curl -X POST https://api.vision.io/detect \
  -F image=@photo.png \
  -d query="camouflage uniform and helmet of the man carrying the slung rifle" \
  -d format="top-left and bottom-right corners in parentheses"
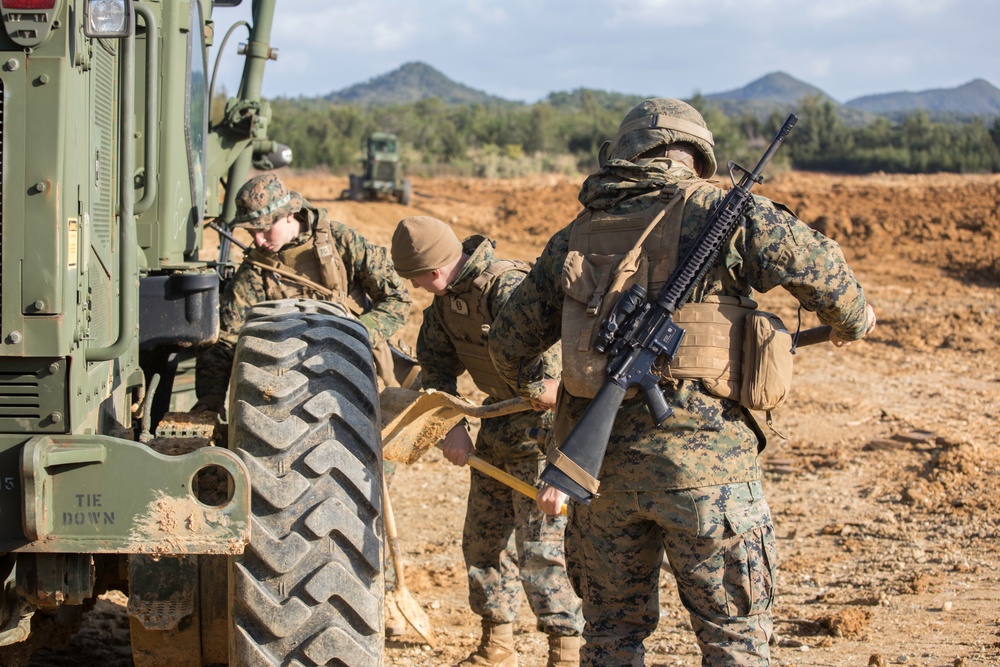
top-left (489, 99), bottom-right (874, 667)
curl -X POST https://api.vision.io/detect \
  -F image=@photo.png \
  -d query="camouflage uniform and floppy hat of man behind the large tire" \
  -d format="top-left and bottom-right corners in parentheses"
top-left (196, 174), bottom-right (412, 412)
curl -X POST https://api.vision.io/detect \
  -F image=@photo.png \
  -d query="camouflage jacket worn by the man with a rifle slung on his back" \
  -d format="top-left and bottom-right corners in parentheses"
top-left (489, 159), bottom-right (866, 492)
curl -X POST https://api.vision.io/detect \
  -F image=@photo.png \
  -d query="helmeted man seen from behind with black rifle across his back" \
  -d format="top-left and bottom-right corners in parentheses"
top-left (489, 99), bottom-right (875, 667)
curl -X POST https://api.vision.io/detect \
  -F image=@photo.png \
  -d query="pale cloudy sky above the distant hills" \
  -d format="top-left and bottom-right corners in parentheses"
top-left (210, 0), bottom-right (1000, 102)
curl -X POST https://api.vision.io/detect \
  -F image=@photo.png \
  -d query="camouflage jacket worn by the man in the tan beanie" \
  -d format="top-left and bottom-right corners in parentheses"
top-left (417, 236), bottom-right (562, 464)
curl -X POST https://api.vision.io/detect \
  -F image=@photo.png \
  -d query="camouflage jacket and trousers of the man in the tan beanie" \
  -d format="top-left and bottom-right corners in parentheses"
top-left (417, 236), bottom-right (583, 636)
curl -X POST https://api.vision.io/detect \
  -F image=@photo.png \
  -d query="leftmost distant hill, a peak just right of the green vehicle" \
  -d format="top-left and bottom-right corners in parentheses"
top-left (323, 62), bottom-right (510, 105)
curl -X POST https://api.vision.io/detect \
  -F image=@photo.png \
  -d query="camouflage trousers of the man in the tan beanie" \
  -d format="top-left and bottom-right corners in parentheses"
top-left (462, 460), bottom-right (583, 636)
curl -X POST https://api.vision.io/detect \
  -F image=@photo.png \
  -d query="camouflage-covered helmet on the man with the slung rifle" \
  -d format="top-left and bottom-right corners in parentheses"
top-left (608, 97), bottom-right (718, 178)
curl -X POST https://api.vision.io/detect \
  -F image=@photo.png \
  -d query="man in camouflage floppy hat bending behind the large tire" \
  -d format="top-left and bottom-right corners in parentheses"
top-left (192, 174), bottom-right (412, 636)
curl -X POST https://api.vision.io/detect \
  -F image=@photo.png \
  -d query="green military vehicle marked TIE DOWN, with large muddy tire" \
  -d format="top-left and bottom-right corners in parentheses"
top-left (0, 0), bottom-right (384, 667)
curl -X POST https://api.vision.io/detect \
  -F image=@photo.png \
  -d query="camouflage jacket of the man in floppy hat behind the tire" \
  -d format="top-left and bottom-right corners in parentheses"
top-left (196, 202), bottom-right (412, 408)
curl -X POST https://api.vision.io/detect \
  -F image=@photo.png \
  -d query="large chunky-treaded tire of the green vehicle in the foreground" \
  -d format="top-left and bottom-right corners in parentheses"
top-left (229, 300), bottom-right (384, 667)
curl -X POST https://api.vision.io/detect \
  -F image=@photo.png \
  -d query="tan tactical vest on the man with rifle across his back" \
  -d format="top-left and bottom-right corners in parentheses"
top-left (561, 180), bottom-right (756, 398)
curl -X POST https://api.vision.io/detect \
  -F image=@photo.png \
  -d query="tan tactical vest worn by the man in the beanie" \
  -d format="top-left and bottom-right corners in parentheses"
top-left (434, 259), bottom-right (530, 399)
